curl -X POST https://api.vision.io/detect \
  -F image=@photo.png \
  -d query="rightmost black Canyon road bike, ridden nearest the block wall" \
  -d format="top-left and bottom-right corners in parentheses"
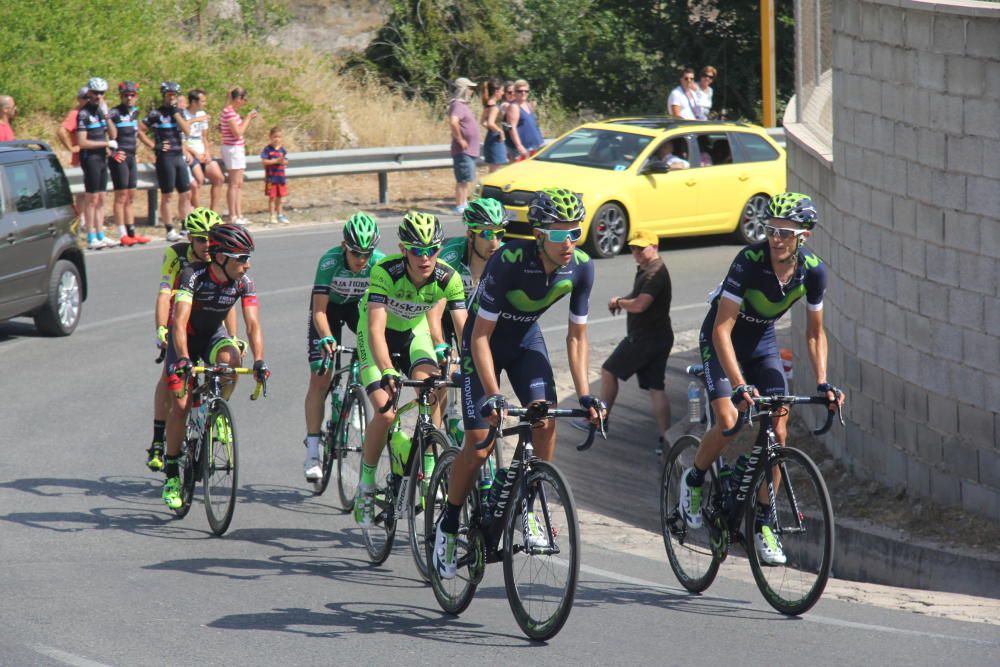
top-left (660, 365), bottom-right (843, 616)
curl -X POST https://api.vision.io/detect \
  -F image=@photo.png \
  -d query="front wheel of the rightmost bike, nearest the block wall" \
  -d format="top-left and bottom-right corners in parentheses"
top-left (745, 447), bottom-right (833, 616)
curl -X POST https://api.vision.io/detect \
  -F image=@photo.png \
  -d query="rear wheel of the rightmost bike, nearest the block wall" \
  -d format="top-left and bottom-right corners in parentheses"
top-left (660, 435), bottom-right (719, 593)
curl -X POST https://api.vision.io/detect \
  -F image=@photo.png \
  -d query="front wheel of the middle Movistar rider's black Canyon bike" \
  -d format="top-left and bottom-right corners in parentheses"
top-left (503, 461), bottom-right (580, 641)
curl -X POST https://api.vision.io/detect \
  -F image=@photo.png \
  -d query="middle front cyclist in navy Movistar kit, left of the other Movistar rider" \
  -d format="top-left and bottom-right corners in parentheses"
top-left (433, 188), bottom-right (604, 578)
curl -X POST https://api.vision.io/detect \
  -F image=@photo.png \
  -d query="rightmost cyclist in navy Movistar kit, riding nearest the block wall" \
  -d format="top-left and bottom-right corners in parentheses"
top-left (680, 192), bottom-right (844, 565)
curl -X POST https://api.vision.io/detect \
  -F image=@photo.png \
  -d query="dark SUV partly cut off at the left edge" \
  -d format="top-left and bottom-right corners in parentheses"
top-left (0, 141), bottom-right (87, 336)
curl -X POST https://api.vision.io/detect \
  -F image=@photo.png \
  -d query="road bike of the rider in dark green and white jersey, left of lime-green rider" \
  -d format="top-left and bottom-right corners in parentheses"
top-left (313, 345), bottom-right (368, 512)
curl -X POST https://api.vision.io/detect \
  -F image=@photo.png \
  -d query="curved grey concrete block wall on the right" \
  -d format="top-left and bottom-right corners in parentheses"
top-left (785, 0), bottom-right (1000, 520)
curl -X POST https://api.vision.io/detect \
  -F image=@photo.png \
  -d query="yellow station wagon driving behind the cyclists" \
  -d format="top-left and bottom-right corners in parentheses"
top-left (480, 117), bottom-right (785, 257)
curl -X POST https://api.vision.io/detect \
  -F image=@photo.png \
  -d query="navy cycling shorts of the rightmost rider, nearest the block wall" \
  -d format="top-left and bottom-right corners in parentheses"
top-left (698, 326), bottom-right (788, 402)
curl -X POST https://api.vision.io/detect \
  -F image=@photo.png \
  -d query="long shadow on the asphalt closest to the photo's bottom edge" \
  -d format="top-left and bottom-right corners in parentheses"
top-left (208, 602), bottom-right (541, 648)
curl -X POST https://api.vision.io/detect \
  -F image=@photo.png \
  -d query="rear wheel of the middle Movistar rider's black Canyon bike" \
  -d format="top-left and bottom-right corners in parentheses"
top-left (424, 448), bottom-right (486, 616)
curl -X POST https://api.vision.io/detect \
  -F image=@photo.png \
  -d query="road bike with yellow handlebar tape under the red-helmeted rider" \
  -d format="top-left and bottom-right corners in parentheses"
top-left (174, 364), bottom-right (267, 535)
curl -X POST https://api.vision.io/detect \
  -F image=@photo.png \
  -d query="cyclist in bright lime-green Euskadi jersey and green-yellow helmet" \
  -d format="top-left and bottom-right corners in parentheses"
top-left (354, 211), bottom-right (466, 529)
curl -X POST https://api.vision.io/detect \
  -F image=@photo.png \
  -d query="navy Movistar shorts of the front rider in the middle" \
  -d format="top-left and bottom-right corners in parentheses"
top-left (461, 322), bottom-right (557, 431)
